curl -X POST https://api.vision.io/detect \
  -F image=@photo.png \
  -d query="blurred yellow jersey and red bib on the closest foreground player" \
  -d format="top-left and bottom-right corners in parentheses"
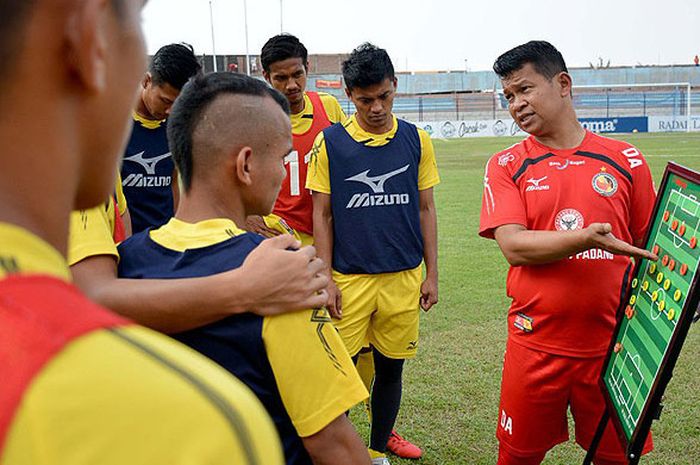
top-left (0, 223), bottom-right (283, 465)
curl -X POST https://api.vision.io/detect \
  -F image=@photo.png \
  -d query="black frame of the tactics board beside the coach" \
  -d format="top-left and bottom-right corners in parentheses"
top-left (584, 162), bottom-right (700, 465)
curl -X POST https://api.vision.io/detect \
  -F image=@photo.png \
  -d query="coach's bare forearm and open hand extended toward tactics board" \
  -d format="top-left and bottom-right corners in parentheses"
top-left (494, 223), bottom-right (657, 266)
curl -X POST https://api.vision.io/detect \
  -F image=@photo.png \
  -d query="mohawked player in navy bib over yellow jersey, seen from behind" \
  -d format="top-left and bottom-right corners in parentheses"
top-left (119, 73), bottom-right (369, 465)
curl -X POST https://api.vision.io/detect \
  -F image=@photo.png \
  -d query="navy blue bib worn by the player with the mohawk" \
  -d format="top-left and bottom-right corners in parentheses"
top-left (118, 230), bottom-right (312, 465)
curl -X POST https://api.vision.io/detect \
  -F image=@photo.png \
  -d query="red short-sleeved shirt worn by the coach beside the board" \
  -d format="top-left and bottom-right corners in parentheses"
top-left (479, 132), bottom-right (656, 357)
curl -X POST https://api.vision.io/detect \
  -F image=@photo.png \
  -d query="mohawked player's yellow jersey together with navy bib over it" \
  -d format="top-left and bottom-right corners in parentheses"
top-left (119, 218), bottom-right (368, 463)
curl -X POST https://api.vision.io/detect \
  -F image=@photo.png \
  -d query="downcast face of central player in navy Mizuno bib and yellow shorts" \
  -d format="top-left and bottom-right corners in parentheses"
top-left (345, 78), bottom-right (397, 134)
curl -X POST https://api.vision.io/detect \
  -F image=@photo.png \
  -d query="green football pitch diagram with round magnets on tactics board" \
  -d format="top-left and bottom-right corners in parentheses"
top-left (603, 165), bottom-right (700, 441)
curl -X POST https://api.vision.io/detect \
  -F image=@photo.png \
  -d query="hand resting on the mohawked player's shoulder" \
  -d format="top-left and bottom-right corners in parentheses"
top-left (241, 234), bottom-right (329, 315)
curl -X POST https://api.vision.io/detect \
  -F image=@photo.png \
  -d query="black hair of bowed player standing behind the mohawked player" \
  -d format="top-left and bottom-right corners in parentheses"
top-left (148, 43), bottom-right (202, 90)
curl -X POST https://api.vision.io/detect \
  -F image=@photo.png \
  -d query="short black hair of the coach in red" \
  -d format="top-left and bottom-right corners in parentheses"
top-left (493, 40), bottom-right (569, 79)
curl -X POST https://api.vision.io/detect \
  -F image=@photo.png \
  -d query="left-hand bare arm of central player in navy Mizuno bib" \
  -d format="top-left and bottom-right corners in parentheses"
top-left (313, 191), bottom-right (343, 319)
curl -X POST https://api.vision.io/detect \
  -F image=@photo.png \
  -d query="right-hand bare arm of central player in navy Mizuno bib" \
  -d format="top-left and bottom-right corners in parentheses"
top-left (418, 187), bottom-right (438, 312)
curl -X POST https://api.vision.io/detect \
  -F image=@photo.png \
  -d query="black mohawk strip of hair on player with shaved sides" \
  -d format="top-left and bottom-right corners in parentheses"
top-left (167, 73), bottom-right (289, 191)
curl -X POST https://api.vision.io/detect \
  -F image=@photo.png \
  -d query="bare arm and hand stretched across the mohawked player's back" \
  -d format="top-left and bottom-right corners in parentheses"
top-left (71, 235), bottom-right (329, 333)
